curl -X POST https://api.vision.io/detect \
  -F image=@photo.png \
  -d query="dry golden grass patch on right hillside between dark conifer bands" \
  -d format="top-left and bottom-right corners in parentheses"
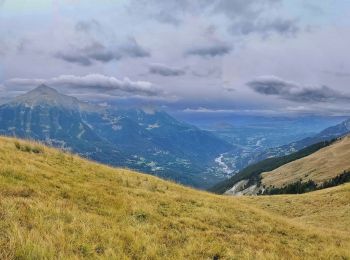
top-left (261, 136), bottom-right (350, 187)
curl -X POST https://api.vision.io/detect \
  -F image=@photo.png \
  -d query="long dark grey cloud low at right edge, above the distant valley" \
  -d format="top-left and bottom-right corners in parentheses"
top-left (246, 76), bottom-right (350, 103)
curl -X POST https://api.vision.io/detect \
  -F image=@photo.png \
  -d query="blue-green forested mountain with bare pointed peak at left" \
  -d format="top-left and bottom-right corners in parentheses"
top-left (0, 85), bottom-right (232, 188)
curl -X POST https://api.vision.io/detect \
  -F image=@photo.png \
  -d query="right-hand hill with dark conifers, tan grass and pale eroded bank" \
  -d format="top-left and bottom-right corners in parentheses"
top-left (211, 136), bottom-right (350, 195)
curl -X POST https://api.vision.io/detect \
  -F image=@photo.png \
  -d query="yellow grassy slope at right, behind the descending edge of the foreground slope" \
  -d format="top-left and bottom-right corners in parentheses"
top-left (238, 184), bottom-right (350, 234)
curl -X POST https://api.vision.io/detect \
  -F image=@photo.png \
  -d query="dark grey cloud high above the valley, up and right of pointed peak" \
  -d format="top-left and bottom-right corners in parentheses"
top-left (55, 38), bottom-right (150, 66)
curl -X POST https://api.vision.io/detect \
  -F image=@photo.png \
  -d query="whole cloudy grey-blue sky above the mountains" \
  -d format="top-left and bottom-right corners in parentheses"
top-left (0, 0), bottom-right (350, 115)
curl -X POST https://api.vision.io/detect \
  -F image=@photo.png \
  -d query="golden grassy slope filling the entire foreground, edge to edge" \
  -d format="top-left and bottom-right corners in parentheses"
top-left (0, 138), bottom-right (350, 259)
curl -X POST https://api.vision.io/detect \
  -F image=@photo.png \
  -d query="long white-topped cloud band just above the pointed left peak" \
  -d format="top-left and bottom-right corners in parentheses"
top-left (5, 74), bottom-right (163, 97)
